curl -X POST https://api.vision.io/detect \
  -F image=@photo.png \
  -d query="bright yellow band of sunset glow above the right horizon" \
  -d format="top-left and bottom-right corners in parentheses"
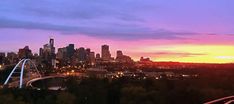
top-left (133, 45), bottom-right (234, 63)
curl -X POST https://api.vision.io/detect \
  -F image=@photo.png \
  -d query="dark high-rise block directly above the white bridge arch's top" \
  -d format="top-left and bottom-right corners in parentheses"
top-left (18, 46), bottom-right (32, 59)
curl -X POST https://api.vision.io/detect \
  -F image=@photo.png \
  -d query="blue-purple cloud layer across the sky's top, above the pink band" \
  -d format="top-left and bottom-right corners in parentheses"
top-left (0, 0), bottom-right (234, 40)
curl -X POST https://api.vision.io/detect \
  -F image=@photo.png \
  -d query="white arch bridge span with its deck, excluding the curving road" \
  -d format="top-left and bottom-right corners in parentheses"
top-left (4, 59), bottom-right (41, 88)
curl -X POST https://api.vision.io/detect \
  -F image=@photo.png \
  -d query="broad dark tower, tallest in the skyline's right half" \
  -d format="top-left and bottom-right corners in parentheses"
top-left (102, 45), bottom-right (111, 61)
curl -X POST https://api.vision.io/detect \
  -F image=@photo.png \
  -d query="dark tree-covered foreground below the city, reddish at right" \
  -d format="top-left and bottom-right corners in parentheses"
top-left (0, 63), bottom-right (234, 104)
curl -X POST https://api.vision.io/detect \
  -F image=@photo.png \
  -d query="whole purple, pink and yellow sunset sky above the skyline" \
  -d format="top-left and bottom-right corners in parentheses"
top-left (0, 0), bottom-right (234, 63)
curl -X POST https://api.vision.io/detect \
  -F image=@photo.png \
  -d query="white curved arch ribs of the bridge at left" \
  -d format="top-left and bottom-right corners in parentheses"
top-left (4, 59), bottom-right (41, 88)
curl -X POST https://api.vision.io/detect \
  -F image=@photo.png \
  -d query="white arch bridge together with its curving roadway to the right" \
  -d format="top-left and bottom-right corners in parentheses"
top-left (4, 59), bottom-right (66, 90)
